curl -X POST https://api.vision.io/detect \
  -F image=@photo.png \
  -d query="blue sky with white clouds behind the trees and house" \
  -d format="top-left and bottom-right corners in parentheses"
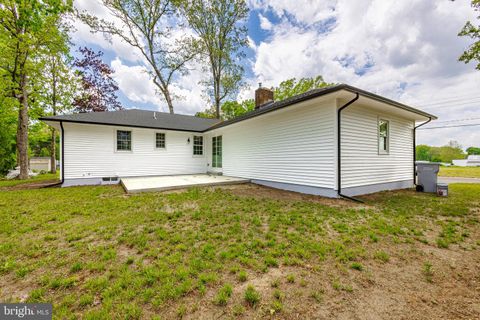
top-left (73, 0), bottom-right (480, 146)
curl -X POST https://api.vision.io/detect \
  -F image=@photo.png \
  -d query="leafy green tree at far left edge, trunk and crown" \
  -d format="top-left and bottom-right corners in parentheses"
top-left (0, 0), bottom-right (72, 179)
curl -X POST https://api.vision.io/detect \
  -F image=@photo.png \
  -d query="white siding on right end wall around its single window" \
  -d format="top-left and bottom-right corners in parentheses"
top-left (342, 105), bottom-right (413, 188)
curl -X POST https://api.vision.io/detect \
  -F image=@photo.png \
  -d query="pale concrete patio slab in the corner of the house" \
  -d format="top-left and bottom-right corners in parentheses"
top-left (120, 174), bottom-right (250, 193)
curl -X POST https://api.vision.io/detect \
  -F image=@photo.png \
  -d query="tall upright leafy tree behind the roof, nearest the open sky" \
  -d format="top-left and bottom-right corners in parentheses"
top-left (180, 0), bottom-right (249, 118)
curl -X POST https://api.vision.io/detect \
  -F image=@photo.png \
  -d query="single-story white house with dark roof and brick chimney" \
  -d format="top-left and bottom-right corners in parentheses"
top-left (42, 84), bottom-right (436, 197)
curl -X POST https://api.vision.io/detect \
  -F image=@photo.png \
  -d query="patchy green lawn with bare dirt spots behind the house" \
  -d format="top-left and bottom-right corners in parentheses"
top-left (0, 181), bottom-right (480, 319)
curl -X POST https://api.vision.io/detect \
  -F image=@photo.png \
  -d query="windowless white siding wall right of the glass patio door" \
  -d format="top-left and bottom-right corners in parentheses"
top-left (206, 100), bottom-right (336, 188)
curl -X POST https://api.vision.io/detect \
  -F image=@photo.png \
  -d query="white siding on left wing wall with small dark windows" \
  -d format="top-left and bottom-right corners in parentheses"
top-left (64, 123), bottom-right (206, 179)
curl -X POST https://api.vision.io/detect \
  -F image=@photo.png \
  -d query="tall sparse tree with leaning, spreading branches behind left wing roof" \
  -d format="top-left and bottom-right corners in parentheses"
top-left (79, 0), bottom-right (198, 114)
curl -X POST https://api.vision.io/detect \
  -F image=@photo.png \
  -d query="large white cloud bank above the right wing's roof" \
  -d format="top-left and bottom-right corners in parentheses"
top-left (252, 0), bottom-right (480, 145)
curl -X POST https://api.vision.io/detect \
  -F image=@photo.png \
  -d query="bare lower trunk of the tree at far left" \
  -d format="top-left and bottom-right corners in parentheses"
top-left (17, 75), bottom-right (29, 179)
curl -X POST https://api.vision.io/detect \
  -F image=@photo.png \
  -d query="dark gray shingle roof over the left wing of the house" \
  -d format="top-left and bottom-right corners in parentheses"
top-left (40, 109), bottom-right (219, 132)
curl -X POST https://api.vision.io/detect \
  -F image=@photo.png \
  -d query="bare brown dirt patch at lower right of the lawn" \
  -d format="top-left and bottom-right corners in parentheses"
top-left (157, 234), bottom-right (480, 320)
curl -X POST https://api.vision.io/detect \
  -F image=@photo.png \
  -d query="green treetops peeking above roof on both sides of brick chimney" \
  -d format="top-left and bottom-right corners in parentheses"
top-left (196, 76), bottom-right (332, 120)
